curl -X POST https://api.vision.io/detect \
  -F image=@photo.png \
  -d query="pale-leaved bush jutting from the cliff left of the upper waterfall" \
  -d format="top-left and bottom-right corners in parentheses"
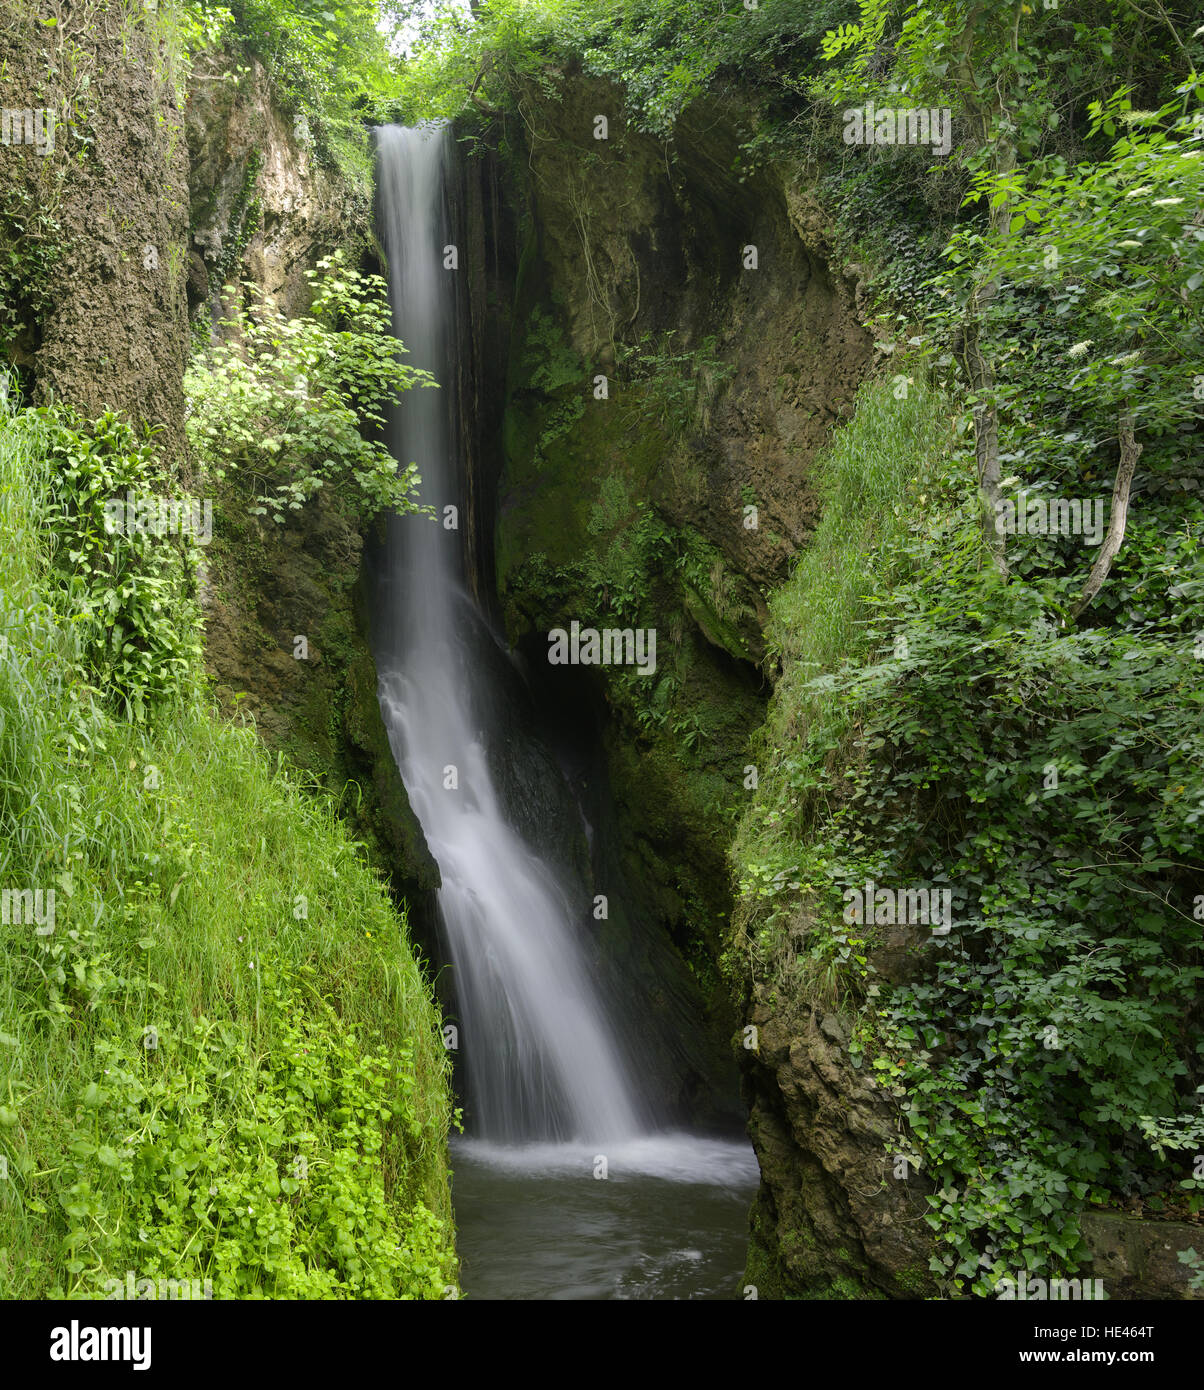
top-left (185, 252), bottom-right (434, 523)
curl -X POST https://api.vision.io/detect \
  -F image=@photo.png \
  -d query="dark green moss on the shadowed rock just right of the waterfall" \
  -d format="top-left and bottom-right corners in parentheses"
top-left (495, 261), bottom-right (763, 1128)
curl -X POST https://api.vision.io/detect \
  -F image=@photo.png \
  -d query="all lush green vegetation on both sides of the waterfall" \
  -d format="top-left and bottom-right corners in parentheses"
top-left (9, 0), bottom-right (1204, 1297)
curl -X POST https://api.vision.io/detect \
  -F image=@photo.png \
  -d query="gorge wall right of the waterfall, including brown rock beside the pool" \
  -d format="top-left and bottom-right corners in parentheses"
top-left (475, 72), bottom-right (1193, 1300)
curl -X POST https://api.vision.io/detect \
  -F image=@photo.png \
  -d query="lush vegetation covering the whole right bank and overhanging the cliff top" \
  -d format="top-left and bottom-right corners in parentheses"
top-left (405, 0), bottom-right (1204, 1294)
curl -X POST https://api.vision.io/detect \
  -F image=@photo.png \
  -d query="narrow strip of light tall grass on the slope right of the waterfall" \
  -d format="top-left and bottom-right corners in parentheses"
top-left (729, 378), bottom-right (954, 969)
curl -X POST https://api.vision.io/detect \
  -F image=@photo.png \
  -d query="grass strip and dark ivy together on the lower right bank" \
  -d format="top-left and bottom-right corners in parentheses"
top-left (730, 366), bottom-right (1204, 1294)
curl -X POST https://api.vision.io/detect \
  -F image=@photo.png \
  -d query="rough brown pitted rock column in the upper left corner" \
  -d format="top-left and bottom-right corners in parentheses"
top-left (0, 3), bottom-right (188, 463)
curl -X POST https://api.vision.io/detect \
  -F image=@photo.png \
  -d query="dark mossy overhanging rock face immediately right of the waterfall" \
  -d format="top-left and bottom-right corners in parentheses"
top-left (495, 74), bottom-right (870, 1128)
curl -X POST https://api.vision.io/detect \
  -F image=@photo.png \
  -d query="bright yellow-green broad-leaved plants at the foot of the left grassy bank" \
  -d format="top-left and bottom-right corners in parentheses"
top-left (61, 965), bottom-right (450, 1298)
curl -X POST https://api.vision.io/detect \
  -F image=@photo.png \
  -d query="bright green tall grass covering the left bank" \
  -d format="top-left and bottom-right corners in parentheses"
top-left (0, 394), bottom-right (455, 1297)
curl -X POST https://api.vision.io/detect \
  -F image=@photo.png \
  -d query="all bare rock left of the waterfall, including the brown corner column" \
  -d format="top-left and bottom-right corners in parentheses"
top-left (0, 16), bottom-right (438, 894)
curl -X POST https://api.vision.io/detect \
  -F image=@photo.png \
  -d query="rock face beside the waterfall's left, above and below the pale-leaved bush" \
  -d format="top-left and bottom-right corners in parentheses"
top-left (188, 56), bottom-right (439, 899)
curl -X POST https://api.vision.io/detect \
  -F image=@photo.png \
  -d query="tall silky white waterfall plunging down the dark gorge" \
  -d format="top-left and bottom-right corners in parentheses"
top-left (375, 126), bottom-right (646, 1144)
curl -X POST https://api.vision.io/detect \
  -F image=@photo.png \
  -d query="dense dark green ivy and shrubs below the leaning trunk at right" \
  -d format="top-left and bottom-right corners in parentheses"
top-left (845, 558), bottom-right (1204, 1289)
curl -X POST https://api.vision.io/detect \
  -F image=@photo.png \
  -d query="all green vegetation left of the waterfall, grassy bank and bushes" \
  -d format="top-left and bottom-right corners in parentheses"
top-left (0, 3), bottom-right (457, 1298)
